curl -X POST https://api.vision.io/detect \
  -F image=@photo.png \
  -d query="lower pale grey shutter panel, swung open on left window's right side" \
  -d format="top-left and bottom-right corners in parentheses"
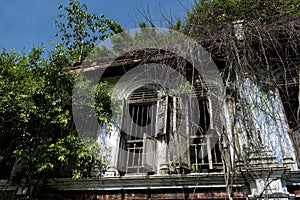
top-left (142, 133), bottom-right (155, 171)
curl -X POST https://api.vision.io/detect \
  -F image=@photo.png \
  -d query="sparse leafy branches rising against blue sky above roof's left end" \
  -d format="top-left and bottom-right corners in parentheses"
top-left (55, 0), bottom-right (123, 64)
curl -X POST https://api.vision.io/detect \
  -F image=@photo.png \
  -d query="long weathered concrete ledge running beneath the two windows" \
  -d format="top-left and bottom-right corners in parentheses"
top-left (46, 173), bottom-right (244, 191)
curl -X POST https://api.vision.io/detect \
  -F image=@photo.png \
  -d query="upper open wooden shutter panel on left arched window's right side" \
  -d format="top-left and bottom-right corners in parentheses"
top-left (155, 97), bottom-right (168, 137)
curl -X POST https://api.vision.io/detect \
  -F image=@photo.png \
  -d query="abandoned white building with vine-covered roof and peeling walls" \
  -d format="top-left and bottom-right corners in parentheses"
top-left (3, 27), bottom-right (300, 200)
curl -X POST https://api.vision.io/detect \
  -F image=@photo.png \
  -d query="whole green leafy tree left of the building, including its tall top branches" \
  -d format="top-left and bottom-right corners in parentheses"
top-left (0, 0), bottom-right (122, 180)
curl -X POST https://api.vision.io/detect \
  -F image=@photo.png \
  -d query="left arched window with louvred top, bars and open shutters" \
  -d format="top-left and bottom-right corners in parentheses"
top-left (118, 85), bottom-right (164, 173)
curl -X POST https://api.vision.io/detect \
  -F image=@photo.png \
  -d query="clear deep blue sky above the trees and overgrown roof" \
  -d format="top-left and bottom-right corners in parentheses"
top-left (0, 0), bottom-right (195, 52)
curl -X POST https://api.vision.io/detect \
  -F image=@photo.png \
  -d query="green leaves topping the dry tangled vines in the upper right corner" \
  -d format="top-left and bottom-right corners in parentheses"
top-left (187, 0), bottom-right (300, 26)
